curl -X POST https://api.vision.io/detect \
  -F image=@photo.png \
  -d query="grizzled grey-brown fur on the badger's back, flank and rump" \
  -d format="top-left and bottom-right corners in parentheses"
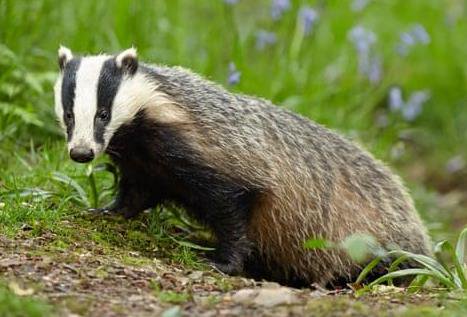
top-left (143, 66), bottom-right (430, 285)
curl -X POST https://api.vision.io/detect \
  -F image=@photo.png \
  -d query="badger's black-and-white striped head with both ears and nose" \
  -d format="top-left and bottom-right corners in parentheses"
top-left (54, 47), bottom-right (141, 163)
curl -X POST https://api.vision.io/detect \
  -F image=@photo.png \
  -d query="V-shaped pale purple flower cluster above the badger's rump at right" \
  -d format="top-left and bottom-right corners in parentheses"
top-left (389, 87), bottom-right (431, 121)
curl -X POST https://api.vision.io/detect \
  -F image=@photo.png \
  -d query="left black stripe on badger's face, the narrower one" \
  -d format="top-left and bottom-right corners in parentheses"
top-left (62, 58), bottom-right (81, 141)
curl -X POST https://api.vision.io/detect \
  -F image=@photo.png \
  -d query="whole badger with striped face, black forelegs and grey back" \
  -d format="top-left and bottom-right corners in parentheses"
top-left (54, 47), bottom-right (430, 286)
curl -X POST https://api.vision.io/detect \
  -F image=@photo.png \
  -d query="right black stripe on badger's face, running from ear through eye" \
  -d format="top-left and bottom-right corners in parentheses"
top-left (94, 58), bottom-right (123, 144)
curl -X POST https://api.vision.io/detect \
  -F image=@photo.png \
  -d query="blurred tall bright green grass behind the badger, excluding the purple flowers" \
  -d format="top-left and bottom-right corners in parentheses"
top-left (0, 0), bottom-right (467, 172)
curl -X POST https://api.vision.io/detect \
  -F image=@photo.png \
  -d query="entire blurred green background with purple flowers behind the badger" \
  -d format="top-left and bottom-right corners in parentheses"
top-left (0, 0), bottom-right (467, 239)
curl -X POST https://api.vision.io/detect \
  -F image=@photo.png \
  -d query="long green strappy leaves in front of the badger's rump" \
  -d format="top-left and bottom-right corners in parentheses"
top-left (305, 227), bottom-right (467, 291)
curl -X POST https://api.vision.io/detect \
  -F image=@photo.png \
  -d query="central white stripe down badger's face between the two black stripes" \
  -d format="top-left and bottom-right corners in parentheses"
top-left (68, 55), bottom-right (110, 155)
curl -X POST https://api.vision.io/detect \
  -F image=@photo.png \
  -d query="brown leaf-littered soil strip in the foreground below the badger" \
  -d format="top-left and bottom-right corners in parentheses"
top-left (0, 228), bottom-right (467, 317)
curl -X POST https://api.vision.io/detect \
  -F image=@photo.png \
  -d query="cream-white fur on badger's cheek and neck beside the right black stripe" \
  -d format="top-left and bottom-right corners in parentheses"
top-left (104, 72), bottom-right (173, 146)
